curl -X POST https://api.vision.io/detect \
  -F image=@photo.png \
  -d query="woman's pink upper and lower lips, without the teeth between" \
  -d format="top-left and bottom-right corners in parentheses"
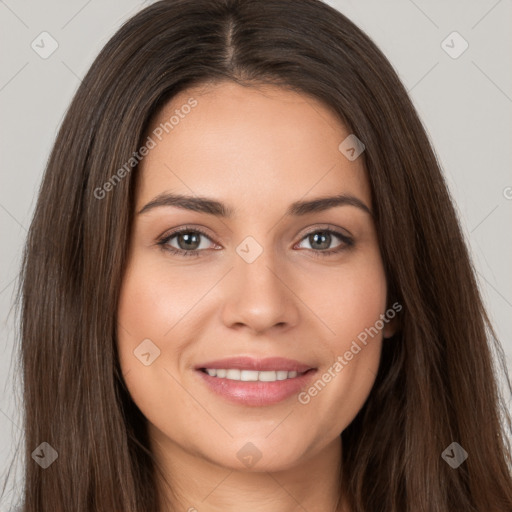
top-left (195, 356), bottom-right (317, 407)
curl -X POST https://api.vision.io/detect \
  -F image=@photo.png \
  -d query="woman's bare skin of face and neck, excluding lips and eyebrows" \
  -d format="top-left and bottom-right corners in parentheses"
top-left (117, 82), bottom-right (395, 512)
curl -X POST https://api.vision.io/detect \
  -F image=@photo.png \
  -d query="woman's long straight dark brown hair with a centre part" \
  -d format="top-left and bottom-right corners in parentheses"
top-left (5, 0), bottom-right (512, 512)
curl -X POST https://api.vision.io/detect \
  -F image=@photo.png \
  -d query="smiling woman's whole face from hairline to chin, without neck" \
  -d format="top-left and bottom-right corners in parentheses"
top-left (117, 82), bottom-right (393, 471)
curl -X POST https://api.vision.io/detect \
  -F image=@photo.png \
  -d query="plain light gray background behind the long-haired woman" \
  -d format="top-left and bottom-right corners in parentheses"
top-left (0, 0), bottom-right (512, 504)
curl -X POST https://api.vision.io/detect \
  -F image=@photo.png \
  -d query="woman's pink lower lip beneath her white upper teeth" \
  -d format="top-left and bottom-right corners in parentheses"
top-left (196, 369), bottom-right (316, 407)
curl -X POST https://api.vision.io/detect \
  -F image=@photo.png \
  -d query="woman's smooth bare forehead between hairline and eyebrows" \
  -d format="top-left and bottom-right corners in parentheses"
top-left (137, 82), bottom-right (371, 212)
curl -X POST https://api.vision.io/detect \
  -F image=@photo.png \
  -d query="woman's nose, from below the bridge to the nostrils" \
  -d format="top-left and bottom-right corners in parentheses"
top-left (222, 242), bottom-right (300, 334)
